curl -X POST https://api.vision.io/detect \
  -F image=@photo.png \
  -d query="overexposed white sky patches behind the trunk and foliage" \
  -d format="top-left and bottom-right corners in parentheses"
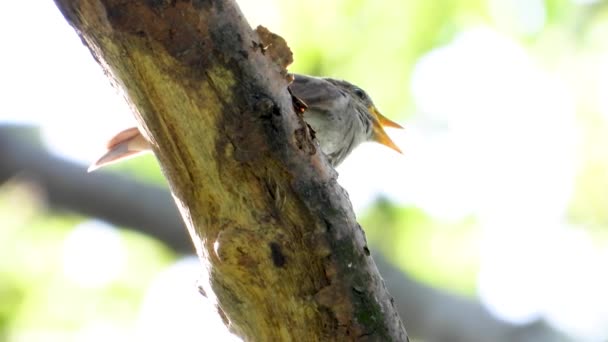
top-left (0, 0), bottom-right (608, 341)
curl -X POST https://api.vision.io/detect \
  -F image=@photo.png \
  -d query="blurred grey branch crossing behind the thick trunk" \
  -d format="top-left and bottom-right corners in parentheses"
top-left (0, 126), bottom-right (565, 342)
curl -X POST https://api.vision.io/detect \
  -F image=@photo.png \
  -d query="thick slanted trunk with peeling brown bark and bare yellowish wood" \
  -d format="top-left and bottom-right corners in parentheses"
top-left (55, 0), bottom-right (407, 341)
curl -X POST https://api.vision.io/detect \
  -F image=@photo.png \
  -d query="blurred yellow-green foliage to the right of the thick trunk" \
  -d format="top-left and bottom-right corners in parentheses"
top-left (279, 0), bottom-right (608, 295)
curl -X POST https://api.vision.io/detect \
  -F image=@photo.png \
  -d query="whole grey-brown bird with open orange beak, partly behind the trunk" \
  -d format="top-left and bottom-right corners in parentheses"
top-left (88, 74), bottom-right (403, 172)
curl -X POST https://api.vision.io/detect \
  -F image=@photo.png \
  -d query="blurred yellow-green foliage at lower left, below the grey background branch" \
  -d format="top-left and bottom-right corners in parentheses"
top-left (0, 180), bottom-right (174, 341)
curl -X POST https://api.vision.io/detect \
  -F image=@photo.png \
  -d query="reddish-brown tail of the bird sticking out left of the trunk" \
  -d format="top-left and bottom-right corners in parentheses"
top-left (88, 127), bottom-right (150, 172)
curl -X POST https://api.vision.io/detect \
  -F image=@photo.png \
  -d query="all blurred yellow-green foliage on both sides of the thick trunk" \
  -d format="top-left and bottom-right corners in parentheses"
top-left (0, 0), bottom-right (608, 341)
